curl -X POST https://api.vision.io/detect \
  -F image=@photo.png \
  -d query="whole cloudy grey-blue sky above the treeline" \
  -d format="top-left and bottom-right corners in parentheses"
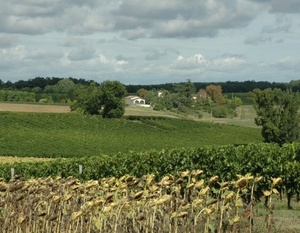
top-left (0, 0), bottom-right (300, 85)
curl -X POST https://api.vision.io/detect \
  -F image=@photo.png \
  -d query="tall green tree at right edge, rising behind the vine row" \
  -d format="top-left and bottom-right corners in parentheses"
top-left (250, 88), bottom-right (300, 145)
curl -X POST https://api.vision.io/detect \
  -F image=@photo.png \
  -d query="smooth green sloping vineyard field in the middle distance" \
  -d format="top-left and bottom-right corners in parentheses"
top-left (0, 109), bottom-right (262, 157)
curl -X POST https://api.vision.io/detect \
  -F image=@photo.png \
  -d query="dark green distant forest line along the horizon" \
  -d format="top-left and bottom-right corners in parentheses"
top-left (0, 77), bottom-right (300, 93)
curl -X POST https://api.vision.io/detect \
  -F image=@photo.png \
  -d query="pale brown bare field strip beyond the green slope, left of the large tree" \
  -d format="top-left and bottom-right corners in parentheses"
top-left (0, 103), bottom-right (70, 113)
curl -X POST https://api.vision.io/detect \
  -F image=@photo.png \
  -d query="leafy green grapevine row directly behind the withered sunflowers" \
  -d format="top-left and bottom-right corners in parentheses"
top-left (0, 143), bottom-right (300, 205)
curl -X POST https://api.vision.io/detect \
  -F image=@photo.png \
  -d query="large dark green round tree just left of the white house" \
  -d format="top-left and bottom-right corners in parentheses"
top-left (71, 81), bottom-right (126, 118)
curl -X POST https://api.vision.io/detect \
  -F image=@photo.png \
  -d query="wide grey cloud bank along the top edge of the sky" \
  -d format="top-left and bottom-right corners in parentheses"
top-left (0, 0), bottom-right (260, 37)
